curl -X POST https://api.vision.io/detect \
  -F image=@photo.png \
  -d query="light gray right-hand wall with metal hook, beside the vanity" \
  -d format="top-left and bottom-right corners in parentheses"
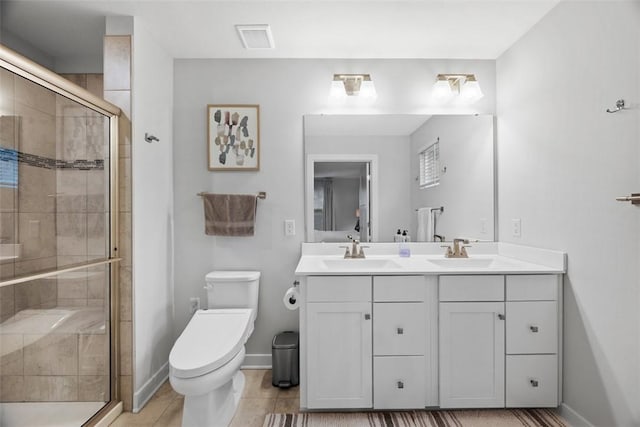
top-left (497, 1), bottom-right (640, 426)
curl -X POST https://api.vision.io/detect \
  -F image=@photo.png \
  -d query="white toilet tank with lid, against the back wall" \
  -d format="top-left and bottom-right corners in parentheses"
top-left (205, 271), bottom-right (260, 312)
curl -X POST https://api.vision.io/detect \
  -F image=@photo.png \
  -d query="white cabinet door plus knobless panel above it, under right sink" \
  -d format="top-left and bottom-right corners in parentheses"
top-left (439, 276), bottom-right (505, 408)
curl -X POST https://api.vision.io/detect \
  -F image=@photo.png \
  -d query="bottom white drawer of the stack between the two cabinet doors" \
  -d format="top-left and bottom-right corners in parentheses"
top-left (373, 356), bottom-right (427, 409)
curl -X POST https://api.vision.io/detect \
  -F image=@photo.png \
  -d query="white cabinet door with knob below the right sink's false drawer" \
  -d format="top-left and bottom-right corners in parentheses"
top-left (440, 302), bottom-right (505, 408)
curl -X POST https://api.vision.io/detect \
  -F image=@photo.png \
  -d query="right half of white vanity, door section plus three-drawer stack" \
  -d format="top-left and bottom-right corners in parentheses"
top-left (439, 274), bottom-right (562, 408)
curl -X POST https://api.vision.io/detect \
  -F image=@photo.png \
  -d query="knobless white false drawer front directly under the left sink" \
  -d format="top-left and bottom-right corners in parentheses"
top-left (306, 276), bottom-right (371, 302)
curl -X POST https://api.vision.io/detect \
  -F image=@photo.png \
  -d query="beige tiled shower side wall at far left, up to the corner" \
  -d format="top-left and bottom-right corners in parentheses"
top-left (0, 69), bottom-right (57, 321)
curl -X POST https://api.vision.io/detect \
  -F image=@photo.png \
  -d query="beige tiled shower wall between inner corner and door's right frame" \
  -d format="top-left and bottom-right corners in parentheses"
top-left (55, 74), bottom-right (109, 310)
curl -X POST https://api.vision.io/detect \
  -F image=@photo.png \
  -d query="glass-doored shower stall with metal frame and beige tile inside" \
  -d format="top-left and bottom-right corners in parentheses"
top-left (0, 46), bottom-right (120, 427)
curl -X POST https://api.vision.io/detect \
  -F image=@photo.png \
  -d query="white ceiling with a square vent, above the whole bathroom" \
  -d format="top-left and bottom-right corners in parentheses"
top-left (1, 0), bottom-right (560, 59)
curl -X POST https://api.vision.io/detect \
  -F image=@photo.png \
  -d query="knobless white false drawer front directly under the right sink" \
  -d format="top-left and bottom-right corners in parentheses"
top-left (439, 275), bottom-right (504, 301)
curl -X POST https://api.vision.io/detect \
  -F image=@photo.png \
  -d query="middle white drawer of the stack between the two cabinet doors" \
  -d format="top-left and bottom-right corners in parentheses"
top-left (373, 302), bottom-right (426, 356)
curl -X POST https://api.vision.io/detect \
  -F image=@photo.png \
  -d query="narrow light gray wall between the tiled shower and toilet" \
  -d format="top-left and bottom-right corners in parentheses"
top-left (131, 18), bottom-right (177, 410)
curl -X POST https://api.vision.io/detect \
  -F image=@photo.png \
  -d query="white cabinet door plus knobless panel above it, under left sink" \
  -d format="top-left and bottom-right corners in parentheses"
top-left (302, 276), bottom-right (373, 409)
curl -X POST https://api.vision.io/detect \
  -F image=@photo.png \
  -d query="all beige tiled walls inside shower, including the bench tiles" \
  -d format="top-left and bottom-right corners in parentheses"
top-left (0, 70), bottom-right (109, 402)
